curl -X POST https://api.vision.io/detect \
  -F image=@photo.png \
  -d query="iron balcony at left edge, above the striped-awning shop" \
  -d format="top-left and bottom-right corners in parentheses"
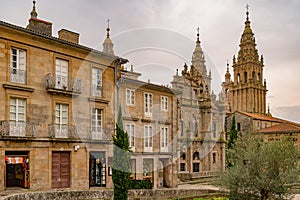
top-left (1, 121), bottom-right (36, 137)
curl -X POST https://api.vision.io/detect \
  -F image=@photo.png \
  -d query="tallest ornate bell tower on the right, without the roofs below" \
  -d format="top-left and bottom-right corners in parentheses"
top-left (222, 5), bottom-right (267, 115)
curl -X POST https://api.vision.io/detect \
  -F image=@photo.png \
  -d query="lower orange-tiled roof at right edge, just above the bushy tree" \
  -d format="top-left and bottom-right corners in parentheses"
top-left (258, 123), bottom-right (300, 133)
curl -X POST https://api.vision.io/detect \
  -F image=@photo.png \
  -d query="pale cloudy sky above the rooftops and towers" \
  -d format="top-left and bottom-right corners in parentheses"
top-left (0, 0), bottom-right (300, 123)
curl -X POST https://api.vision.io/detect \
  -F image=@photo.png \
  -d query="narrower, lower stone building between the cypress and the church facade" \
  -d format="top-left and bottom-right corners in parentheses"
top-left (120, 66), bottom-right (178, 188)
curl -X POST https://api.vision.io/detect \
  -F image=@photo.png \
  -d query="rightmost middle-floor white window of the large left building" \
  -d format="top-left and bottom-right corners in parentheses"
top-left (92, 108), bottom-right (103, 139)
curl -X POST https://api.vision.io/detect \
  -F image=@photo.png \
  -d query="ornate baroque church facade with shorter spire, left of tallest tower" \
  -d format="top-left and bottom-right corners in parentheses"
top-left (172, 29), bottom-right (225, 180)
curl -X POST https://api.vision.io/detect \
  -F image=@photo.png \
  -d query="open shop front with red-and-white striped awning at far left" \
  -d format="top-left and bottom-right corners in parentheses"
top-left (5, 151), bottom-right (30, 188)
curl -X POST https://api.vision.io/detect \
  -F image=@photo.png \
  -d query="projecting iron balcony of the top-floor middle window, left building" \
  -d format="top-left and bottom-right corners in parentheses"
top-left (46, 73), bottom-right (81, 96)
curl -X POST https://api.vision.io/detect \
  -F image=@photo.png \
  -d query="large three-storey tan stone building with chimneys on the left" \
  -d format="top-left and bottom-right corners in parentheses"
top-left (0, 2), bottom-right (127, 191)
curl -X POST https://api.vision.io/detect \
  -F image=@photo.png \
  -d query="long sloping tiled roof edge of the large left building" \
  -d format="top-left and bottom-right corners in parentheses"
top-left (0, 20), bottom-right (128, 64)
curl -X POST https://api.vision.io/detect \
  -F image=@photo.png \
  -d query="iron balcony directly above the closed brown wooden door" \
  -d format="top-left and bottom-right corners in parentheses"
top-left (48, 124), bottom-right (79, 139)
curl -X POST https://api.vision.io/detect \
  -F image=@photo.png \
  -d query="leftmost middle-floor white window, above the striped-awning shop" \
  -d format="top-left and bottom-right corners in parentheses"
top-left (9, 98), bottom-right (26, 136)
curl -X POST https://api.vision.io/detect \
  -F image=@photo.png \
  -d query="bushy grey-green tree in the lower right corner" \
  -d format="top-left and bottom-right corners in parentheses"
top-left (217, 133), bottom-right (299, 200)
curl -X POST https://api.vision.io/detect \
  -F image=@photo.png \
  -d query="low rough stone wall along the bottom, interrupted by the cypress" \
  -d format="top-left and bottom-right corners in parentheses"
top-left (0, 189), bottom-right (225, 200)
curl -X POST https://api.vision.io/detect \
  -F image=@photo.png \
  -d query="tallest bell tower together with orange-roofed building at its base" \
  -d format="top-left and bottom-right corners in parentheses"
top-left (222, 8), bottom-right (300, 155)
